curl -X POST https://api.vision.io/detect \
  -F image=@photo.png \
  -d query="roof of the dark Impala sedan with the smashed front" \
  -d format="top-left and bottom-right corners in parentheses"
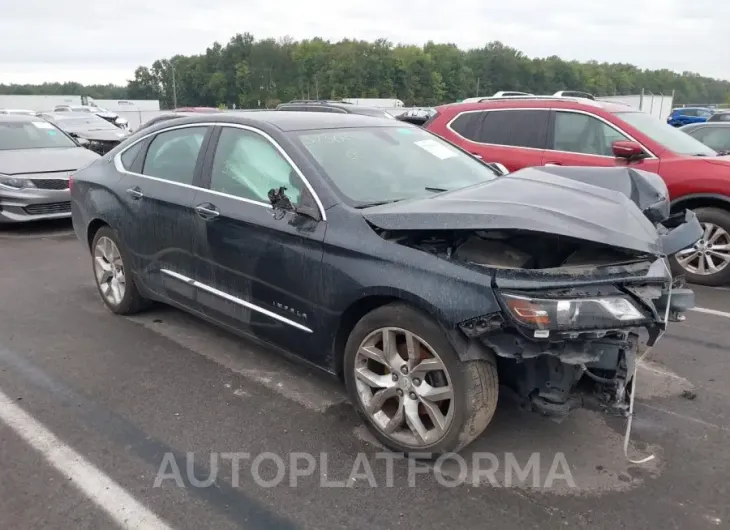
top-left (138, 110), bottom-right (404, 131)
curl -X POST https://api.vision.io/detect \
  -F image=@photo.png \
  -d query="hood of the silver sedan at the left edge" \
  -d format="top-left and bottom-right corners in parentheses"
top-left (0, 147), bottom-right (99, 175)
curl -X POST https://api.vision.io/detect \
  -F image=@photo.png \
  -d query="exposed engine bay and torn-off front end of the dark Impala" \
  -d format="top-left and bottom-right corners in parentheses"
top-left (375, 228), bottom-right (694, 416)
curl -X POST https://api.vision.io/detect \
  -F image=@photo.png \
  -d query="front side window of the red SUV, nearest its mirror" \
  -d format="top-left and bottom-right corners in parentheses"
top-left (553, 112), bottom-right (628, 156)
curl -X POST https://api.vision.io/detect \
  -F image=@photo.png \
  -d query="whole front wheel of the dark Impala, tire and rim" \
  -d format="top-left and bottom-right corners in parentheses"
top-left (344, 303), bottom-right (499, 455)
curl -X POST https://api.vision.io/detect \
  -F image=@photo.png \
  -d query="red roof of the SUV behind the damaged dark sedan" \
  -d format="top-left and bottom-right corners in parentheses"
top-left (437, 96), bottom-right (639, 112)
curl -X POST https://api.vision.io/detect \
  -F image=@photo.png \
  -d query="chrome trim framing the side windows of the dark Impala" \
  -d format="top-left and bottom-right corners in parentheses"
top-left (114, 122), bottom-right (327, 221)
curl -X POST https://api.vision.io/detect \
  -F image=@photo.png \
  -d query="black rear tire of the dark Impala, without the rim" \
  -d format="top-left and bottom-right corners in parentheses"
top-left (91, 226), bottom-right (150, 315)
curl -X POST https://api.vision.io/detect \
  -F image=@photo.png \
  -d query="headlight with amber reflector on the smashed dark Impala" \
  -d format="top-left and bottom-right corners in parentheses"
top-left (502, 293), bottom-right (651, 330)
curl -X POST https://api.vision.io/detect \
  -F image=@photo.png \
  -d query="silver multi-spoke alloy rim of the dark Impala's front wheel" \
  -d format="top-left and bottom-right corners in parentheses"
top-left (354, 327), bottom-right (455, 447)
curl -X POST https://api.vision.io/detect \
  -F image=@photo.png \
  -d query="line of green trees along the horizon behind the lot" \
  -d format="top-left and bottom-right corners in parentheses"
top-left (0, 33), bottom-right (730, 108)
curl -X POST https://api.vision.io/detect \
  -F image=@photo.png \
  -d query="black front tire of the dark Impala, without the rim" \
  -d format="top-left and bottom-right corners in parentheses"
top-left (343, 303), bottom-right (499, 458)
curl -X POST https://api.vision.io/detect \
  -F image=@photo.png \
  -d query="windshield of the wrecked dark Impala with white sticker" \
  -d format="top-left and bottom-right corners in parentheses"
top-left (290, 127), bottom-right (497, 207)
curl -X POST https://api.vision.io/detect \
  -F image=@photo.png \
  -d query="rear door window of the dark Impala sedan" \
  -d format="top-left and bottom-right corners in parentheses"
top-left (142, 127), bottom-right (207, 184)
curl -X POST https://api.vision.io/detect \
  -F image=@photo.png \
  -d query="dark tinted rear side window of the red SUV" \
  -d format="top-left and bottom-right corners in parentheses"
top-left (451, 109), bottom-right (550, 149)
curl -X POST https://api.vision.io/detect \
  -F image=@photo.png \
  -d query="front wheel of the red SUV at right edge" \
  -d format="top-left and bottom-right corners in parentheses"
top-left (674, 208), bottom-right (730, 285)
